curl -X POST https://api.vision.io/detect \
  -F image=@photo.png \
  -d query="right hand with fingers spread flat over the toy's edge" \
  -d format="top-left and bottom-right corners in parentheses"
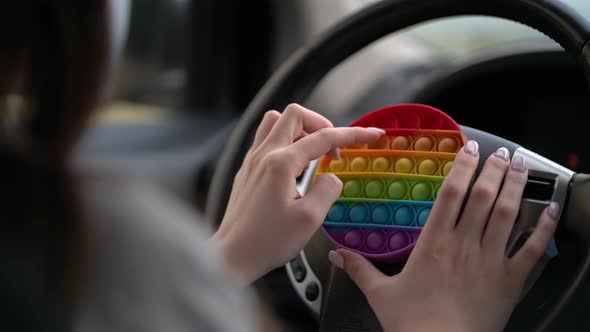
top-left (329, 141), bottom-right (559, 332)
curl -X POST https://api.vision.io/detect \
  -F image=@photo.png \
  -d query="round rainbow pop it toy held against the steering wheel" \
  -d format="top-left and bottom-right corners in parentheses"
top-left (315, 104), bottom-right (466, 262)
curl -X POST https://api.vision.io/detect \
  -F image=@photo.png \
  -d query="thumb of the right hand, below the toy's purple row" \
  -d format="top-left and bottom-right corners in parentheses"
top-left (328, 249), bottom-right (387, 296)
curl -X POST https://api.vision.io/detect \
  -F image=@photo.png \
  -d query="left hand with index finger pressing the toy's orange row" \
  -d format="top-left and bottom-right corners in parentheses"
top-left (212, 104), bottom-right (384, 283)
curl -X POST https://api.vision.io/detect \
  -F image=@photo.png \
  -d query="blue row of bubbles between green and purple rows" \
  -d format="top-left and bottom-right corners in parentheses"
top-left (324, 200), bottom-right (432, 227)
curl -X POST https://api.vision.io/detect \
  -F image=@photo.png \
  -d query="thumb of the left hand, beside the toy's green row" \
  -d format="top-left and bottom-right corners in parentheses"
top-left (302, 173), bottom-right (342, 221)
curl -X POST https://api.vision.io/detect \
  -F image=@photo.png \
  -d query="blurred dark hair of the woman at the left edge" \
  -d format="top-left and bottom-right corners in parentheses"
top-left (0, 0), bottom-right (108, 329)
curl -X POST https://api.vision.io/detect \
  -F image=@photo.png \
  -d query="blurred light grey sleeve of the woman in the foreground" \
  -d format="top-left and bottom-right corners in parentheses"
top-left (78, 171), bottom-right (260, 331)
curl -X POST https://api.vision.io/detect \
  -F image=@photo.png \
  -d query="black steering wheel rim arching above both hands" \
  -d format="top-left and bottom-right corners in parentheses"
top-left (206, 0), bottom-right (590, 326)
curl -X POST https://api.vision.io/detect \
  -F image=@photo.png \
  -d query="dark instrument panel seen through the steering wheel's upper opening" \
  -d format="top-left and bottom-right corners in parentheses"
top-left (409, 40), bottom-right (590, 172)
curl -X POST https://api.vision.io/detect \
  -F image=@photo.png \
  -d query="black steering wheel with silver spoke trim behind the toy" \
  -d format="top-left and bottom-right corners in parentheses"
top-left (206, 0), bottom-right (590, 331)
